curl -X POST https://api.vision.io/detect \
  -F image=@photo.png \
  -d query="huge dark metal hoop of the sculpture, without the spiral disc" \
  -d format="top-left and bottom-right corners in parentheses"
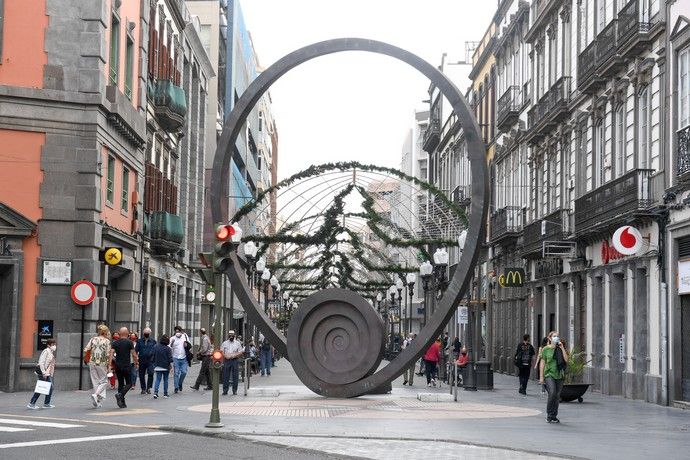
top-left (211, 38), bottom-right (489, 397)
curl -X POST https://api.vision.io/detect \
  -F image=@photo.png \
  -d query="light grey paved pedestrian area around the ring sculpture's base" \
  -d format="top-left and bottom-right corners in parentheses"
top-left (0, 360), bottom-right (690, 460)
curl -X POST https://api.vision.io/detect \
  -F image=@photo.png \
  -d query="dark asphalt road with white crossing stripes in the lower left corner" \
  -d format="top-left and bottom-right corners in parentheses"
top-left (0, 416), bottom-right (350, 460)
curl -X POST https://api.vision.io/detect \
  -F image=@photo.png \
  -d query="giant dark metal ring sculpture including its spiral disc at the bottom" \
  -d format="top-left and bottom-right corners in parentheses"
top-left (211, 38), bottom-right (489, 397)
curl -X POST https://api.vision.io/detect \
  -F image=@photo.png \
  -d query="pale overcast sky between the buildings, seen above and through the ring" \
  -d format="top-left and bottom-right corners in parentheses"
top-left (241, 0), bottom-right (496, 178)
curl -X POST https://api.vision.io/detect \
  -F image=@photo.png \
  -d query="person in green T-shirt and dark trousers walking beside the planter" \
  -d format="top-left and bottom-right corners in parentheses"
top-left (539, 331), bottom-right (568, 423)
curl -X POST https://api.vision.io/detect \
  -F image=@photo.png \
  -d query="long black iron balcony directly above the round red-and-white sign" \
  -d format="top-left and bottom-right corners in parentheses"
top-left (575, 169), bottom-right (653, 236)
